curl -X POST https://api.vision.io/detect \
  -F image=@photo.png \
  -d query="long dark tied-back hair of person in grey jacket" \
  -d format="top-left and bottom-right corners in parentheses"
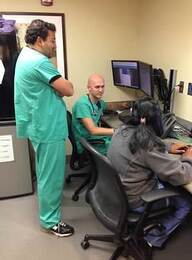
top-left (123, 97), bottom-right (165, 154)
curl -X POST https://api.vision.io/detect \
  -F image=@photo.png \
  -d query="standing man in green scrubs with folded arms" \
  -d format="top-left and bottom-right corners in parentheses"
top-left (15, 19), bottom-right (74, 237)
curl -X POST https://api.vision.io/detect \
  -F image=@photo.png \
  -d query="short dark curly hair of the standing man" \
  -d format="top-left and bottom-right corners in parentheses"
top-left (25, 19), bottom-right (56, 44)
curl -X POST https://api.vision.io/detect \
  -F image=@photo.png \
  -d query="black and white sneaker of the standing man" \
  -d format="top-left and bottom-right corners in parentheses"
top-left (49, 222), bottom-right (74, 237)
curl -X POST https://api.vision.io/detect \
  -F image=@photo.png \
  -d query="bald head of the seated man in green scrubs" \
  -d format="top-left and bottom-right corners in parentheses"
top-left (87, 74), bottom-right (105, 102)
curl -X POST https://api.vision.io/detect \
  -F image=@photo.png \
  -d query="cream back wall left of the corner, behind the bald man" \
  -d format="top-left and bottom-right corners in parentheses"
top-left (1, 0), bottom-right (139, 108)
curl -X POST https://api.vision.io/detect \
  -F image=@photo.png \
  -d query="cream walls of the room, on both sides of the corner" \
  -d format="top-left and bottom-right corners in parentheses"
top-left (0, 0), bottom-right (192, 146)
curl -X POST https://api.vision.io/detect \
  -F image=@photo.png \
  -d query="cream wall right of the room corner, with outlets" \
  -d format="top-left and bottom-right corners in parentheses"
top-left (138, 0), bottom-right (192, 121)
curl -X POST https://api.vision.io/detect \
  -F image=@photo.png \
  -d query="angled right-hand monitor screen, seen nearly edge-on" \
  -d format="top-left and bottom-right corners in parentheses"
top-left (139, 62), bottom-right (153, 97)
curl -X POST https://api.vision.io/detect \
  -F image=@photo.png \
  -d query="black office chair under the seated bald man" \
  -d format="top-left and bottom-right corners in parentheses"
top-left (65, 111), bottom-right (91, 201)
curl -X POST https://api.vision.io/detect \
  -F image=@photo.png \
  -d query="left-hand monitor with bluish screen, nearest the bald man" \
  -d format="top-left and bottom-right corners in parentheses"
top-left (111, 60), bottom-right (139, 89)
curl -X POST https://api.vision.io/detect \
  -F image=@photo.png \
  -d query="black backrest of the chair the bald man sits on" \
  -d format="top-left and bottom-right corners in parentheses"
top-left (67, 111), bottom-right (87, 170)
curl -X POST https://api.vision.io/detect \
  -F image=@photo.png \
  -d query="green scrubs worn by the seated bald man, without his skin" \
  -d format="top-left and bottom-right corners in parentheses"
top-left (72, 95), bottom-right (111, 154)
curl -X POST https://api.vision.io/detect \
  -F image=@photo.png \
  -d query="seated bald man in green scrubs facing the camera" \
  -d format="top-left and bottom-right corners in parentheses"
top-left (72, 74), bottom-right (127, 155)
